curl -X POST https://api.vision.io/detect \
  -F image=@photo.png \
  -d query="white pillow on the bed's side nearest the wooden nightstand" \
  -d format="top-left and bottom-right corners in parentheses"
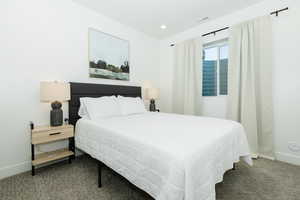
top-left (80, 96), bottom-right (121, 120)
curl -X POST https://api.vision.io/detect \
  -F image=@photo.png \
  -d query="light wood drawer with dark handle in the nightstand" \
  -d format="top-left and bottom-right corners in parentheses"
top-left (31, 128), bottom-right (74, 144)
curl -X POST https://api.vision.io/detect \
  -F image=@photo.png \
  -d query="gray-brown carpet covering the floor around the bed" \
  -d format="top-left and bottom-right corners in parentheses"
top-left (0, 156), bottom-right (300, 200)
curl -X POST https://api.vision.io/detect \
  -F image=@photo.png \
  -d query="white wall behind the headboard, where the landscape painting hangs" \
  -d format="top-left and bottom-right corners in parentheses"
top-left (0, 0), bottom-right (159, 179)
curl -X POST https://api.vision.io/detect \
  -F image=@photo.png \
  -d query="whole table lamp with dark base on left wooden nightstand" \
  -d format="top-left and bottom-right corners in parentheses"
top-left (40, 81), bottom-right (70, 126)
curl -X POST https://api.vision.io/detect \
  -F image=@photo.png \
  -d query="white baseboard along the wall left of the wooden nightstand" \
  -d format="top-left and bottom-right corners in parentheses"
top-left (0, 161), bottom-right (31, 180)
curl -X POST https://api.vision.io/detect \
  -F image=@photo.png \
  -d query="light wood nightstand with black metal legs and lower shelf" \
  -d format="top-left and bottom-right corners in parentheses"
top-left (31, 125), bottom-right (75, 176)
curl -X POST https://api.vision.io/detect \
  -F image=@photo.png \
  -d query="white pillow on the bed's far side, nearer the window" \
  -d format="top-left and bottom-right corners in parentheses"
top-left (118, 96), bottom-right (147, 115)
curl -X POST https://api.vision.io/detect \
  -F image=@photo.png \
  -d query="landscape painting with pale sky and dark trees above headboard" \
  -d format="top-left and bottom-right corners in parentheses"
top-left (89, 28), bottom-right (130, 81)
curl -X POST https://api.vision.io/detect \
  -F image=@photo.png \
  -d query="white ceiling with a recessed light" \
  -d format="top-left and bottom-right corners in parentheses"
top-left (74, 0), bottom-right (262, 39)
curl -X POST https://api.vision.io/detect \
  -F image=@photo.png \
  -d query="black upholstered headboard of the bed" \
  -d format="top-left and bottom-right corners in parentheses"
top-left (69, 82), bottom-right (142, 126)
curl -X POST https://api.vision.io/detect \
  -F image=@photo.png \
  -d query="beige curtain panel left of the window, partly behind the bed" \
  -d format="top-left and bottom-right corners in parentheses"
top-left (173, 38), bottom-right (202, 115)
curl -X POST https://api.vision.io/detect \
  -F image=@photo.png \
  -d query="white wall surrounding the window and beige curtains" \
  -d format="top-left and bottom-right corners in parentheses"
top-left (160, 0), bottom-right (300, 165)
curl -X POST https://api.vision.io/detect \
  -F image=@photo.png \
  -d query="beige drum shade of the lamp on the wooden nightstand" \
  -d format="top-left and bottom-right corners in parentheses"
top-left (40, 81), bottom-right (70, 102)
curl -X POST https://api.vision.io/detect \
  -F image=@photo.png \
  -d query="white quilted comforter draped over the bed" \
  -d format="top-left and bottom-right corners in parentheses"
top-left (76, 113), bottom-right (252, 200)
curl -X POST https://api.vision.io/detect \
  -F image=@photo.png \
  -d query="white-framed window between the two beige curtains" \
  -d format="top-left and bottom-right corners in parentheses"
top-left (202, 41), bottom-right (228, 96)
